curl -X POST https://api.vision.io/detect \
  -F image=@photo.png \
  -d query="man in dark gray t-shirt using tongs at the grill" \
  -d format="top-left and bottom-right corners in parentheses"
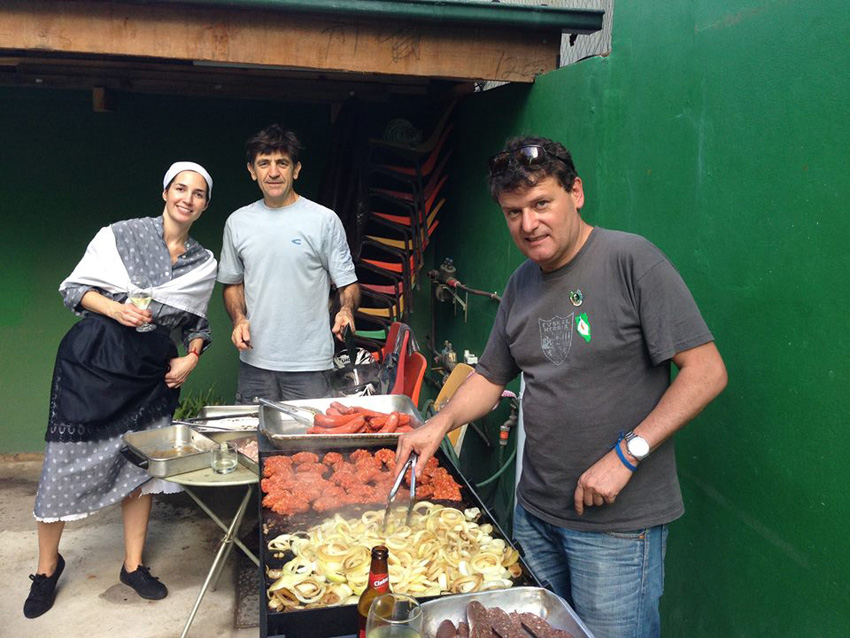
top-left (396, 138), bottom-right (726, 638)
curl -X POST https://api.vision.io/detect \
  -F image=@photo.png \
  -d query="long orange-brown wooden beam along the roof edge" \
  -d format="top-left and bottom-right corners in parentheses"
top-left (0, 0), bottom-right (560, 82)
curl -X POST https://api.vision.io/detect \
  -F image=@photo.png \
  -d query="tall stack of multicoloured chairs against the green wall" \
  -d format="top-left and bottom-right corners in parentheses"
top-left (355, 103), bottom-right (454, 336)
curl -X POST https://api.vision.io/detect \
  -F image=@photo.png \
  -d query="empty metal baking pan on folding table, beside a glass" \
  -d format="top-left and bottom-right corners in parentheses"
top-left (123, 425), bottom-right (216, 478)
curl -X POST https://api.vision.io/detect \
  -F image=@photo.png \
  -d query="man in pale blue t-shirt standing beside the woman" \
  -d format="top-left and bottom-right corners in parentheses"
top-left (218, 124), bottom-right (360, 403)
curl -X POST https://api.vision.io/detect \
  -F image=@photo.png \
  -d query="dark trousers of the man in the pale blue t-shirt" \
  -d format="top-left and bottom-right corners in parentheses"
top-left (236, 361), bottom-right (332, 405)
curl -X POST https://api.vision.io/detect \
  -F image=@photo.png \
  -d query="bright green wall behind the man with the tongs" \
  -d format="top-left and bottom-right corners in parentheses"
top-left (428, 0), bottom-right (850, 637)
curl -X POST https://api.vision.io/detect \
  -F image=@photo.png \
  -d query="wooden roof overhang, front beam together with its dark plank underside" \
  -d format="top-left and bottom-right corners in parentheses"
top-left (0, 0), bottom-right (588, 102)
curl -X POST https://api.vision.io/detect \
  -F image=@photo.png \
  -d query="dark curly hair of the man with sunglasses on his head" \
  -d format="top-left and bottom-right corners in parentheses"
top-left (487, 136), bottom-right (578, 202)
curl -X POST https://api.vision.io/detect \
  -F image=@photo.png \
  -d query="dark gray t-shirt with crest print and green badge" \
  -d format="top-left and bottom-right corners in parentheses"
top-left (477, 228), bottom-right (713, 531)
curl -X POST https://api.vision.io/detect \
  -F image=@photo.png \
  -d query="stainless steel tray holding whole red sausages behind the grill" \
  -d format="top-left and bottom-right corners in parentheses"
top-left (259, 394), bottom-right (422, 451)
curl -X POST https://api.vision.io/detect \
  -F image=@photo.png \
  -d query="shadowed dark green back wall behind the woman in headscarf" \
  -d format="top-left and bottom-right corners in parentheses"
top-left (0, 89), bottom-right (331, 453)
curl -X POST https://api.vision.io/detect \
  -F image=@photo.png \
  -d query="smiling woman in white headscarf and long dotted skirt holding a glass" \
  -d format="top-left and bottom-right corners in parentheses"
top-left (24, 162), bottom-right (217, 618)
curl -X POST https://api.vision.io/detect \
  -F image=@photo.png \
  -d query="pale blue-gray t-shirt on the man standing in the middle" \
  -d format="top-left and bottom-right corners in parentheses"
top-left (218, 197), bottom-right (357, 372)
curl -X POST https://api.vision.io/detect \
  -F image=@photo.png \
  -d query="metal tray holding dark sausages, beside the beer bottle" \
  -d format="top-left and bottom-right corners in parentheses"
top-left (422, 587), bottom-right (593, 638)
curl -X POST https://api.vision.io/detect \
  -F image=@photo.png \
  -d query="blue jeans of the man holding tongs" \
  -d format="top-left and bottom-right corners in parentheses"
top-left (514, 505), bottom-right (667, 638)
